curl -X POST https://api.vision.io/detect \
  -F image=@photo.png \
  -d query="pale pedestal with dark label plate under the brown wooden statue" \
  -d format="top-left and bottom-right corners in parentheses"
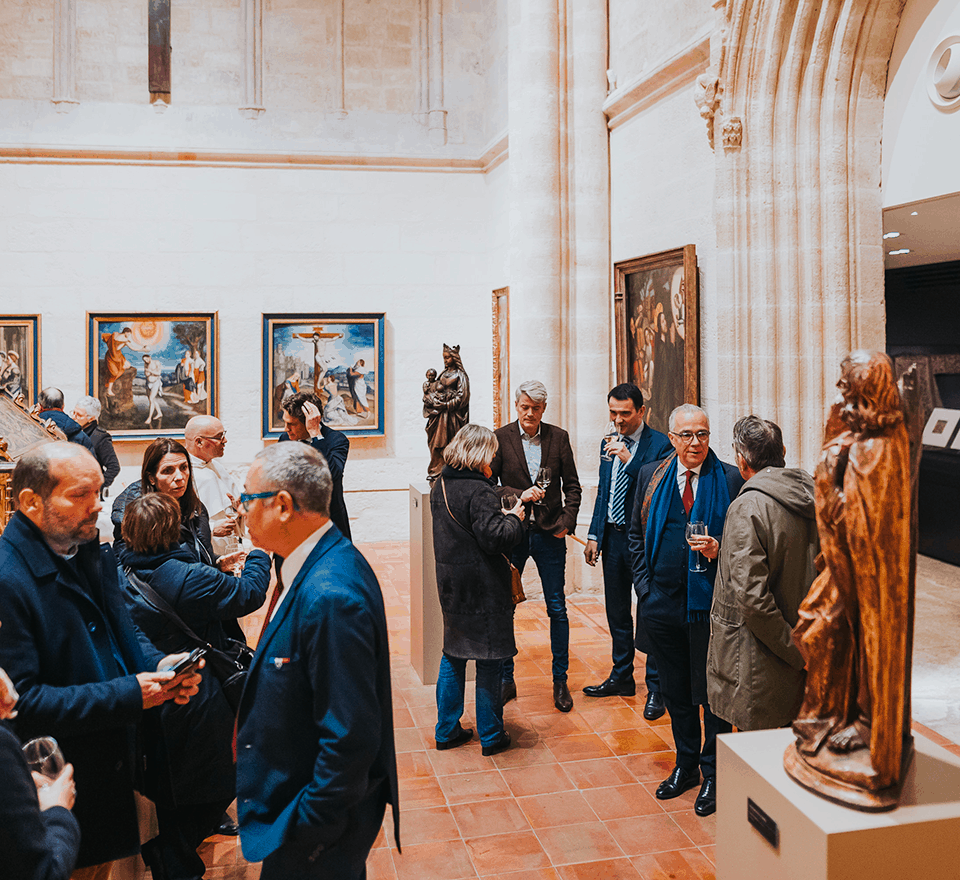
top-left (717, 729), bottom-right (960, 880)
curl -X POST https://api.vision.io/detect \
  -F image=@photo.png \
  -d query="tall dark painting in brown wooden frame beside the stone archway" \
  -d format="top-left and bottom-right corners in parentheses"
top-left (613, 244), bottom-right (700, 433)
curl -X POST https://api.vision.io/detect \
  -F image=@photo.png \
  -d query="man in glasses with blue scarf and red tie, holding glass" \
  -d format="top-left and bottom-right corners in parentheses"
top-left (627, 403), bottom-right (744, 816)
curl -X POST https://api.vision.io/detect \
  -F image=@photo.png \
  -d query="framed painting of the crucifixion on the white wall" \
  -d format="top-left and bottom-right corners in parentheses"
top-left (263, 312), bottom-right (384, 437)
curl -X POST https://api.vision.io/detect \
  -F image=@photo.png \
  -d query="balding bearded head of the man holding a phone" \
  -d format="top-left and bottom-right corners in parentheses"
top-left (11, 443), bottom-right (103, 556)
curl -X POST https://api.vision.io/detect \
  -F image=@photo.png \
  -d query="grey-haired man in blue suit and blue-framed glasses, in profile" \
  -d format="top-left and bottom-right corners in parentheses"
top-left (237, 443), bottom-right (400, 880)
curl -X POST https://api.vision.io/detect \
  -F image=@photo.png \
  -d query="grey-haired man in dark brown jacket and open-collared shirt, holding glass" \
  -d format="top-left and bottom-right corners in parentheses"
top-left (490, 381), bottom-right (581, 712)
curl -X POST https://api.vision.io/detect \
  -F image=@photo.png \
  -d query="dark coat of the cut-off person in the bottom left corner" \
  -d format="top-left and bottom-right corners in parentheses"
top-left (0, 721), bottom-right (80, 880)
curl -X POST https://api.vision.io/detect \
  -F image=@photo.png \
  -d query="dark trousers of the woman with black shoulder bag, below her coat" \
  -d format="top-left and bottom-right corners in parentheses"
top-left (148, 799), bottom-right (230, 880)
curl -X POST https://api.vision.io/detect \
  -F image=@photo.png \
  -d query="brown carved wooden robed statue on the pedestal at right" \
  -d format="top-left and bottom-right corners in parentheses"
top-left (784, 351), bottom-right (921, 811)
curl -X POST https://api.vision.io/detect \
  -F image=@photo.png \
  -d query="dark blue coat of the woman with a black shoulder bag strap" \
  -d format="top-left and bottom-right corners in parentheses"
top-left (120, 546), bottom-right (270, 804)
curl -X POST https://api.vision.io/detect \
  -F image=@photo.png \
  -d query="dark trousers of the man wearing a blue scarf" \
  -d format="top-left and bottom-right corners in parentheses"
top-left (640, 592), bottom-right (733, 779)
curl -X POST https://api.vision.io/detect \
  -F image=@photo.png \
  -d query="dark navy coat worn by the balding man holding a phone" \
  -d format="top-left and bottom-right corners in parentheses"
top-left (0, 512), bottom-right (163, 867)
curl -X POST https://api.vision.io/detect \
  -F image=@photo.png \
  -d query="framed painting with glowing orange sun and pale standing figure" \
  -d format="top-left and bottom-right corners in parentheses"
top-left (87, 312), bottom-right (219, 440)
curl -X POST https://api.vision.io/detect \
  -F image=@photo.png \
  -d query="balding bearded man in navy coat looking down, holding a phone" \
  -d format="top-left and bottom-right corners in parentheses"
top-left (0, 443), bottom-right (200, 877)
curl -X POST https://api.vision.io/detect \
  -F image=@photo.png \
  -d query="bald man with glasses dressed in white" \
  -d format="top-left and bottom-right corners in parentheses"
top-left (183, 416), bottom-right (243, 556)
